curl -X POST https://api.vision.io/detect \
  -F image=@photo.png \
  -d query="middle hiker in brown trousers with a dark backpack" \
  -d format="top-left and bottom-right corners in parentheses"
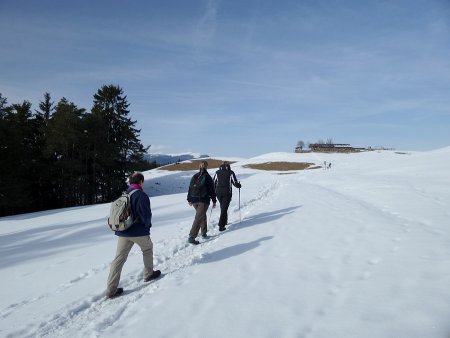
top-left (187, 161), bottom-right (217, 245)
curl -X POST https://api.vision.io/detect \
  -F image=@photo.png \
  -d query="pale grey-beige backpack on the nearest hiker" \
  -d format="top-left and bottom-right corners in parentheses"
top-left (108, 189), bottom-right (138, 231)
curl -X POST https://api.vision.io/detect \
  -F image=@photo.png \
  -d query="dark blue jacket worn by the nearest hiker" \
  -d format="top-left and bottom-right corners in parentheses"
top-left (116, 188), bottom-right (152, 237)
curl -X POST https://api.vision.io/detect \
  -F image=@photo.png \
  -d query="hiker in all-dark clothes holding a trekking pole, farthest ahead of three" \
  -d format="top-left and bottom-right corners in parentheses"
top-left (214, 161), bottom-right (241, 231)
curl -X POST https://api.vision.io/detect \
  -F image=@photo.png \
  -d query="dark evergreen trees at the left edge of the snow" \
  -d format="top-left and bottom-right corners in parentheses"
top-left (0, 85), bottom-right (157, 216)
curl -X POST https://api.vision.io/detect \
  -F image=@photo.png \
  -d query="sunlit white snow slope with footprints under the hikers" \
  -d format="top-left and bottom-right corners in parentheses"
top-left (0, 147), bottom-right (450, 338)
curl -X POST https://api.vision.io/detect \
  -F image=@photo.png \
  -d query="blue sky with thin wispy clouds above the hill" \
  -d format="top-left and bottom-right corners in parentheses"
top-left (0, 0), bottom-right (450, 157)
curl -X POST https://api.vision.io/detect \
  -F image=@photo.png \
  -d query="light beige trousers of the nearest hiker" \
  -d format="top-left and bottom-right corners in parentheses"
top-left (106, 236), bottom-right (153, 296)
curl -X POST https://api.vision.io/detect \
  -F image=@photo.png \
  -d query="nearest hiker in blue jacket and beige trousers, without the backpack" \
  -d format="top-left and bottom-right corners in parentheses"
top-left (106, 172), bottom-right (161, 298)
